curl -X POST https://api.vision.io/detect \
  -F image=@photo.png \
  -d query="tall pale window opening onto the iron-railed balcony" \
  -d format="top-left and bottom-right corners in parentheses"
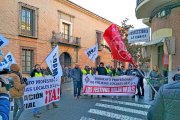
top-left (62, 22), bottom-right (70, 40)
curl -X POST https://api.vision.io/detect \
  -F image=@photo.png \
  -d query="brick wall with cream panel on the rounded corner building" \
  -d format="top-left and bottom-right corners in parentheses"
top-left (151, 7), bottom-right (180, 70)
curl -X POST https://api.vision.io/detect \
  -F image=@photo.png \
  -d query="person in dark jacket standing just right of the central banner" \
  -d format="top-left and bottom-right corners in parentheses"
top-left (149, 65), bottom-right (162, 100)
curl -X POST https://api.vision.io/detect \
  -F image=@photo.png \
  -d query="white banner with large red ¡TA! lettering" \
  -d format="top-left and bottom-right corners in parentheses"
top-left (11, 76), bottom-right (60, 110)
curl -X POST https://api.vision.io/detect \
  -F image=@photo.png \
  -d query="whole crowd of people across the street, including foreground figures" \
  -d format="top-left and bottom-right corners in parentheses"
top-left (0, 62), bottom-right (180, 120)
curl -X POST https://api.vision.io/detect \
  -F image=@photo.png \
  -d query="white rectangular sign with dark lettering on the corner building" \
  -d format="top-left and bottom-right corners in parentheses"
top-left (128, 28), bottom-right (150, 43)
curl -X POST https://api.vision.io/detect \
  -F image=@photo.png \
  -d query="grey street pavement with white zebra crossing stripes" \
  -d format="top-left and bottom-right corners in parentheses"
top-left (10, 80), bottom-right (152, 120)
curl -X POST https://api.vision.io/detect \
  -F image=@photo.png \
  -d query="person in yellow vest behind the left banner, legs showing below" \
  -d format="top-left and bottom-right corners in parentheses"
top-left (30, 64), bottom-right (43, 118)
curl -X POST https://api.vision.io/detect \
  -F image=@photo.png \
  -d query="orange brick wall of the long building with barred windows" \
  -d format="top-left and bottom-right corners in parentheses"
top-left (0, 0), bottom-right (112, 71)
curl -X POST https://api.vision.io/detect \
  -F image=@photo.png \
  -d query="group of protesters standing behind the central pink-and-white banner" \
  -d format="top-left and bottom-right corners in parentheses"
top-left (70, 62), bottom-right (144, 99)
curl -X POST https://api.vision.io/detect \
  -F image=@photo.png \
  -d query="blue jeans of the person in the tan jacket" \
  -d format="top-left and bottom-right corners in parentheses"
top-left (13, 97), bottom-right (24, 120)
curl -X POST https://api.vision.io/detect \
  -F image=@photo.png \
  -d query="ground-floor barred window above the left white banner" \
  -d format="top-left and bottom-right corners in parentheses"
top-left (22, 48), bottom-right (34, 73)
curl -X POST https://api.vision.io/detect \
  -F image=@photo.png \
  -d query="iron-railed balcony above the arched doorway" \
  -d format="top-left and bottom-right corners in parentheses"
top-left (50, 32), bottom-right (81, 47)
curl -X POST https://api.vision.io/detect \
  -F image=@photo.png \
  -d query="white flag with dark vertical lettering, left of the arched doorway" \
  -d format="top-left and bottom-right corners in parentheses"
top-left (46, 46), bottom-right (62, 78)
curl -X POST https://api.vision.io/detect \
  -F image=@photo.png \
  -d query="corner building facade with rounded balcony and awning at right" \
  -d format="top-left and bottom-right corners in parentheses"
top-left (136, 0), bottom-right (180, 80)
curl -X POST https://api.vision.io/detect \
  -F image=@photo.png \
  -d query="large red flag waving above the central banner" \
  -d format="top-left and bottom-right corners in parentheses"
top-left (103, 24), bottom-right (136, 67)
